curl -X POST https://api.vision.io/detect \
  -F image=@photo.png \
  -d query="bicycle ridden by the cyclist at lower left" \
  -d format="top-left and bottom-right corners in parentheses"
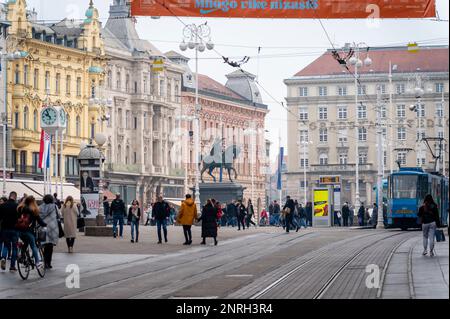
top-left (17, 230), bottom-right (45, 280)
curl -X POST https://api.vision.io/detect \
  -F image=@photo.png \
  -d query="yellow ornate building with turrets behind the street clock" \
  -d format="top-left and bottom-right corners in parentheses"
top-left (6, 0), bottom-right (106, 180)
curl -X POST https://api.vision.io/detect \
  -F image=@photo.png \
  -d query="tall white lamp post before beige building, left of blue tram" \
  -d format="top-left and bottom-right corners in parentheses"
top-left (349, 42), bottom-right (372, 215)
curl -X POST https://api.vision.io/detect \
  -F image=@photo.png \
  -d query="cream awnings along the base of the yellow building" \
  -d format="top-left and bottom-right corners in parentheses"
top-left (6, 179), bottom-right (80, 202)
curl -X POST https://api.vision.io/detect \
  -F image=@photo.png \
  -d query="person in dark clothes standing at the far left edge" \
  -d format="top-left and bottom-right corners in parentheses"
top-left (0, 192), bottom-right (19, 272)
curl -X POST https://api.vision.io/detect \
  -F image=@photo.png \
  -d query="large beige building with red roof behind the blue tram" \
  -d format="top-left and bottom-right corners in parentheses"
top-left (284, 47), bottom-right (449, 208)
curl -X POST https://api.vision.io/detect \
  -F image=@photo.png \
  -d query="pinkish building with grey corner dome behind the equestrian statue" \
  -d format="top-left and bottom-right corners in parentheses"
top-left (166, 51), bottom-right (268, 213)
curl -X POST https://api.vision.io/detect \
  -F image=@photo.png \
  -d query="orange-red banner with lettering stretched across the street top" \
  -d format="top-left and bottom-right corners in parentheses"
top-left (131, 0), bottom-right (436, 19)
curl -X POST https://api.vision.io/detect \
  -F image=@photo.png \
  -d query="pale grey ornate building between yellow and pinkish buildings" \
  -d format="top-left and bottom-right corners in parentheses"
top-left (102, 0), bottom-right (184, 205)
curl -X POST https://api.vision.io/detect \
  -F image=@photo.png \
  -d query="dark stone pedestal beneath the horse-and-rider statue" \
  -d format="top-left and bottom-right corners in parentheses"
top-left (191, 182), bottom-right (246, 205)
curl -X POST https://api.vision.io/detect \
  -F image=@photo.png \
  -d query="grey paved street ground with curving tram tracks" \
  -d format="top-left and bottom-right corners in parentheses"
top-left (0, 227), bottom-right (449, 299)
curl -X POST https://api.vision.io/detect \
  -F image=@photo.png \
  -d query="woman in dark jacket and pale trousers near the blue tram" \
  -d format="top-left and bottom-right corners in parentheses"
top-left (417, 194), bottom-right (441, 257)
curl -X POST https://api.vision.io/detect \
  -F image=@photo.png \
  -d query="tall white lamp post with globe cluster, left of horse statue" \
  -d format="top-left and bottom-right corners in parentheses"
top-left (180, 23), bottom-right (214, 211)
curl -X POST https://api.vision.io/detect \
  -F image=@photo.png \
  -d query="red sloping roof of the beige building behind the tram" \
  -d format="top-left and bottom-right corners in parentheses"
top-left (295, 46), bottom-right (449, 77)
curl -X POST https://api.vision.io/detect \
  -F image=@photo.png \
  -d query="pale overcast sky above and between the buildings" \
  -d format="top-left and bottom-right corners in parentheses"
top-left (22, 0), bottom-right (449, 160)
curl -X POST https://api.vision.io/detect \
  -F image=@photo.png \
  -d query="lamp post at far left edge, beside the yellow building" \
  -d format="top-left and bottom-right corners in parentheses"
top-left (0, 51), bottom-right (23, 196)
